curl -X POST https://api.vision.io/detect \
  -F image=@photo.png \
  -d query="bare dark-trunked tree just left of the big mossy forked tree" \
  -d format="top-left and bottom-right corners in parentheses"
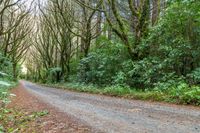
top-left (65, 0), bottom-right (101, 58)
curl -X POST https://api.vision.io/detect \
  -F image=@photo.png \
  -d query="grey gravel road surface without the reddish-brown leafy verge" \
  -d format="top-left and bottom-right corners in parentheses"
top-left (22, 81), bottom-right (200, 133)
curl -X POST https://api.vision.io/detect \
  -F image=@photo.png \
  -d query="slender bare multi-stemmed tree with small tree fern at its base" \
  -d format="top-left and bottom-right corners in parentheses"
top-left (30, 0), bottom-right (76, 82)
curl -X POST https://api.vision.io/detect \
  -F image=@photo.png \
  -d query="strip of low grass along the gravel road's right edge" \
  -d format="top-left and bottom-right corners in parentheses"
top-left (46, 83), bottom-right (200, 106)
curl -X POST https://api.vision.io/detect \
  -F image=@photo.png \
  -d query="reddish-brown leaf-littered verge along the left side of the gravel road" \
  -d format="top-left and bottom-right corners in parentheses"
top-left (8, 84), bottom-right (92, 133)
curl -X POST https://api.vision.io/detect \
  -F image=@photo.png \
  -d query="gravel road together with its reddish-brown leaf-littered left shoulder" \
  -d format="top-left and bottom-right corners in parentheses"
top-left (6, 81), bottom-right (200, 133)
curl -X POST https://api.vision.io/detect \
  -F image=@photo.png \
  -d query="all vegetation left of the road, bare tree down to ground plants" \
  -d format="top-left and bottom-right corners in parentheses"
top-left (0, 0), bottom-right (48, 133)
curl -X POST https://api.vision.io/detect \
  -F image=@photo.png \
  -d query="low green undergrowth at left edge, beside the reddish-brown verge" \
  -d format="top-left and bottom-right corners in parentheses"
top-left (0, 79), bottom-right (48, 133)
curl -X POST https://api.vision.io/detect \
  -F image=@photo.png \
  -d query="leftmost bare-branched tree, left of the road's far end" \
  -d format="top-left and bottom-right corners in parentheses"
top-left (0, 0), bottom-right (31, 79)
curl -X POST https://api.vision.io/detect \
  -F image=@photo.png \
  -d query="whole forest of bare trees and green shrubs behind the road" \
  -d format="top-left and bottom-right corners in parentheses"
top-left (0, 0), bottom-right (200, 105)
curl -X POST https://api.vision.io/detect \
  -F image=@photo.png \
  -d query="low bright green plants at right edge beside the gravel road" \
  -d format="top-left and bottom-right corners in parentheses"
top-left (153, 79), bottom-right (200, 105)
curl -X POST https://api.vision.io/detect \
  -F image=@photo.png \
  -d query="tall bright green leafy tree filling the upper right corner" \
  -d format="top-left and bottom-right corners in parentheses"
top-left (150, 1), bottom-right (200, 76)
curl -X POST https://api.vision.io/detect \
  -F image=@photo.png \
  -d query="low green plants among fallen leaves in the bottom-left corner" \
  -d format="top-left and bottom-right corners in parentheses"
top-left (0, 109), bottom-right (48, 133)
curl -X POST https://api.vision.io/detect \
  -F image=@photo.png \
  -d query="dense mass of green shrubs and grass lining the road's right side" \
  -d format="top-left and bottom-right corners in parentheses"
top-left (27, 0), bottom-right (200, 105)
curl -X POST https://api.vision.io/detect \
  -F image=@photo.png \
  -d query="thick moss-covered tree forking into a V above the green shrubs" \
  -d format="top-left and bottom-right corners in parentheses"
top-left (103, 0), bottom-right (150, 61)
